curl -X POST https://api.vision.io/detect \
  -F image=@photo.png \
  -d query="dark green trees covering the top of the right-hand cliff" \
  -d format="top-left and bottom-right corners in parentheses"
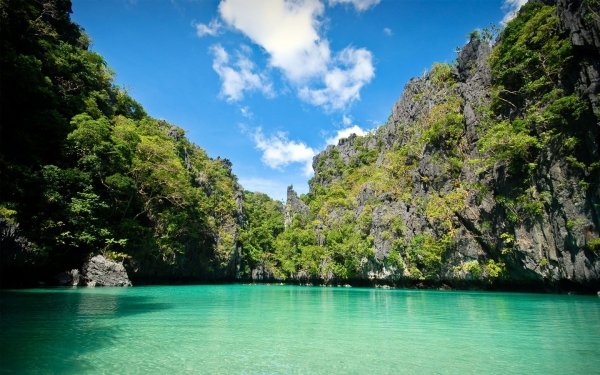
top-left (479, 2), bottom-right (593, 178)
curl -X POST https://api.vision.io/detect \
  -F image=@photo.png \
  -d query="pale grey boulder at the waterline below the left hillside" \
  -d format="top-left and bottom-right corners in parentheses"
top-left (82, 255), bottom-right (131, 286)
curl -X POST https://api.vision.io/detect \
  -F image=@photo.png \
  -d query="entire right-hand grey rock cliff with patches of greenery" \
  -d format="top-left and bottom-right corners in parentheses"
top-left (288, 0), bottom-right (600, 288)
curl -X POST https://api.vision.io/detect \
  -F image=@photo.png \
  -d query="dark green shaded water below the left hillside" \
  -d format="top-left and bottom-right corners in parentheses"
top-left (0, 288), bottom-right (169, 373)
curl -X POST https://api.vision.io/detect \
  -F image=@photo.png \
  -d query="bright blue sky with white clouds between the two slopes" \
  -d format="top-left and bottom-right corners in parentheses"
top-left (72, 0), bottom-right (525, 200)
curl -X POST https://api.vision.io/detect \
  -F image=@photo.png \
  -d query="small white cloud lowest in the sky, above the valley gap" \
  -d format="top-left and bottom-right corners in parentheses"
top-left (253, 128), bottom-right (317, 177)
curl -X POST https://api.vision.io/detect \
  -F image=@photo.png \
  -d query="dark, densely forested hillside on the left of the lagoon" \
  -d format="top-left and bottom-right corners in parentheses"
top-left (0, 0), bottom-right (241, 284)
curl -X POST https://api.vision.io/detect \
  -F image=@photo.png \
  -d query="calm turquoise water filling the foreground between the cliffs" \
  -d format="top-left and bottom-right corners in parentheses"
top-left (0, 285), bottom-right (600, 374)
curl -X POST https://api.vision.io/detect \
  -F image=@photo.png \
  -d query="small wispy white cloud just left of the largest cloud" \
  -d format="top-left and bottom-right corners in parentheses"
top-left (210, 44), bottom-right (273, 102)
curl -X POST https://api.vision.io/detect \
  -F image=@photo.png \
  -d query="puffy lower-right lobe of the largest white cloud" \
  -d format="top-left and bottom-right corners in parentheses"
top-left (300, 47), bottom-right (375, 110)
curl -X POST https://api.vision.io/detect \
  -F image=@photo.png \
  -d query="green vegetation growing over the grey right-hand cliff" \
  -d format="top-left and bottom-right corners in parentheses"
top-left (268, 2), bottom-right (595, 288)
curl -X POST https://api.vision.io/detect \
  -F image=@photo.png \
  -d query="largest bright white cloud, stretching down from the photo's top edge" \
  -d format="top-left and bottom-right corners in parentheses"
top-left (219, 0), bottom-right (378, 110)
